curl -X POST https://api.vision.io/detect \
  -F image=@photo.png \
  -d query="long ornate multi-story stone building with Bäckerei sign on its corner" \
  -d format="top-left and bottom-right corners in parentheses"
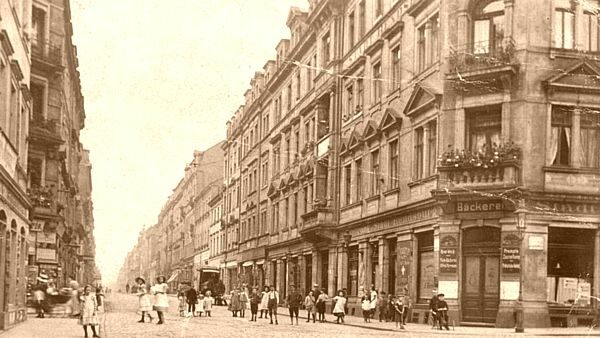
top-left (119, 0), bottom-right (600, 327)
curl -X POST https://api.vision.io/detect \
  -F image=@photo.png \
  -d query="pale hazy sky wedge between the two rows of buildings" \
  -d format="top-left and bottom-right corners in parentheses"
top-left (71, 0), bottom-right (307, 282)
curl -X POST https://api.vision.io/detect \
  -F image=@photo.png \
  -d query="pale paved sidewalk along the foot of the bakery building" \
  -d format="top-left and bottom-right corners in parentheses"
top-left (278, 307), bottom-right (600, 337)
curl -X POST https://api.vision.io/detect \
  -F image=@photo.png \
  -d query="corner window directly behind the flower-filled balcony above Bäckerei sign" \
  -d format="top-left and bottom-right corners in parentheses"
top-left (467, 106), bottom-right (502, 154)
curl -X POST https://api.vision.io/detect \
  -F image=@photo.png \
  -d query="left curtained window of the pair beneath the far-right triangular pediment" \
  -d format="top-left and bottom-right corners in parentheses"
top-left (550, 106), bottom-right (571, 166)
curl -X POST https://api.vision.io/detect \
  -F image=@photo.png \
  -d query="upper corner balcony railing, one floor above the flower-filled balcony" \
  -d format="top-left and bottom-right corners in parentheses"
top-left (449, 39), bottom-right (516, 72)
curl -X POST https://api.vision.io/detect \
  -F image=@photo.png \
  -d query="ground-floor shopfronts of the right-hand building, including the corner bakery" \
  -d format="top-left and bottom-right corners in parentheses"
top-left (252, 197), bottom-right (600, 327)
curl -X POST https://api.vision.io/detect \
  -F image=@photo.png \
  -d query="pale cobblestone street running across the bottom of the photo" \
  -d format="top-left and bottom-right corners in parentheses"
top-left (0, 294), bottom-right (598, 338)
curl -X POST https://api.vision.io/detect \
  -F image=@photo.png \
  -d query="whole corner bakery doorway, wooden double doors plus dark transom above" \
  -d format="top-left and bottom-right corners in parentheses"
top-left (462, 227), bottom-right (500, 323)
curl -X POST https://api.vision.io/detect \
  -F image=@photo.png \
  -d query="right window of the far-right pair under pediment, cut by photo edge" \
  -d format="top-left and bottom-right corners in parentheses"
top-left (580, 111), bottom-right (600, 168)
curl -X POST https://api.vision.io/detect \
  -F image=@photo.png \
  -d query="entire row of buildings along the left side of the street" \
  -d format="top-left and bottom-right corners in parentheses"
top-left (0, 0), bottom-right (100, 331)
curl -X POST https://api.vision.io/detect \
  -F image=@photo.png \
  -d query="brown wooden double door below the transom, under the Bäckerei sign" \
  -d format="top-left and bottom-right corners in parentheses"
top-left (462, 255), bottom-right (500, 323)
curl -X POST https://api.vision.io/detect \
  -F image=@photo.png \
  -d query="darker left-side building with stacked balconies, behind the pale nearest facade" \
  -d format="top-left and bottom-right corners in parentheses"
top-left (27, 0), bottom-right (93, 294)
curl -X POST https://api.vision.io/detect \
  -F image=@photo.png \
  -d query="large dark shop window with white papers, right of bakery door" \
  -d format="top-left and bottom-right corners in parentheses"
top-left (547, 227), bottom-right (596, 307)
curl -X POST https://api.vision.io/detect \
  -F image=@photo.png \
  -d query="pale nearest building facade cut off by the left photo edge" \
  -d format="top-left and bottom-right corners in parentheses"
top-left (0, 1), bottom-right (31, 331)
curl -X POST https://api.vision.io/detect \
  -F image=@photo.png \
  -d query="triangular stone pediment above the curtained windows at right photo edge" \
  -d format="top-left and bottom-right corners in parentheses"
top-left (544, 60), bottom-right (600, 92)
